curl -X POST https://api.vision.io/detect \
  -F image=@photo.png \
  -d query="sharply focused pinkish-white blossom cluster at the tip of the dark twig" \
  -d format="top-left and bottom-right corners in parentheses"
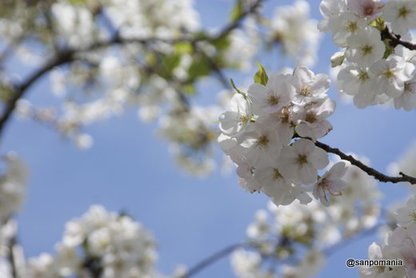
top-left (218, 67), bottom-right (346, 205)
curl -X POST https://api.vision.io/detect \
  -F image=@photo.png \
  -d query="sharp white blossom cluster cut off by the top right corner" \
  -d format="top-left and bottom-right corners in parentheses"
top-left (319, 0), bottom-right (416, 111)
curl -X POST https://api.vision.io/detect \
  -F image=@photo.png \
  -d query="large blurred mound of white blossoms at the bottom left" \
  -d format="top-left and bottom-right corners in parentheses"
top-left (25, 206), bottom-right (160, 278)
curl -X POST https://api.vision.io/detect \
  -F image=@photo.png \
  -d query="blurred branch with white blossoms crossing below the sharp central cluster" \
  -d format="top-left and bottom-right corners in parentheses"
top-left (181, 193), bottom-right (385, 278)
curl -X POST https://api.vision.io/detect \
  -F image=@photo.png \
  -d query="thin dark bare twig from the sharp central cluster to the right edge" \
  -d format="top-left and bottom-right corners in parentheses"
top-left (315, 141), bottom-right (416, 184)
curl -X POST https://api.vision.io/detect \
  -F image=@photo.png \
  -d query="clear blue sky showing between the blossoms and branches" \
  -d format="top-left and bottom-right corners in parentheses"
top-left (1, 0), bottom-right (416, 278)
